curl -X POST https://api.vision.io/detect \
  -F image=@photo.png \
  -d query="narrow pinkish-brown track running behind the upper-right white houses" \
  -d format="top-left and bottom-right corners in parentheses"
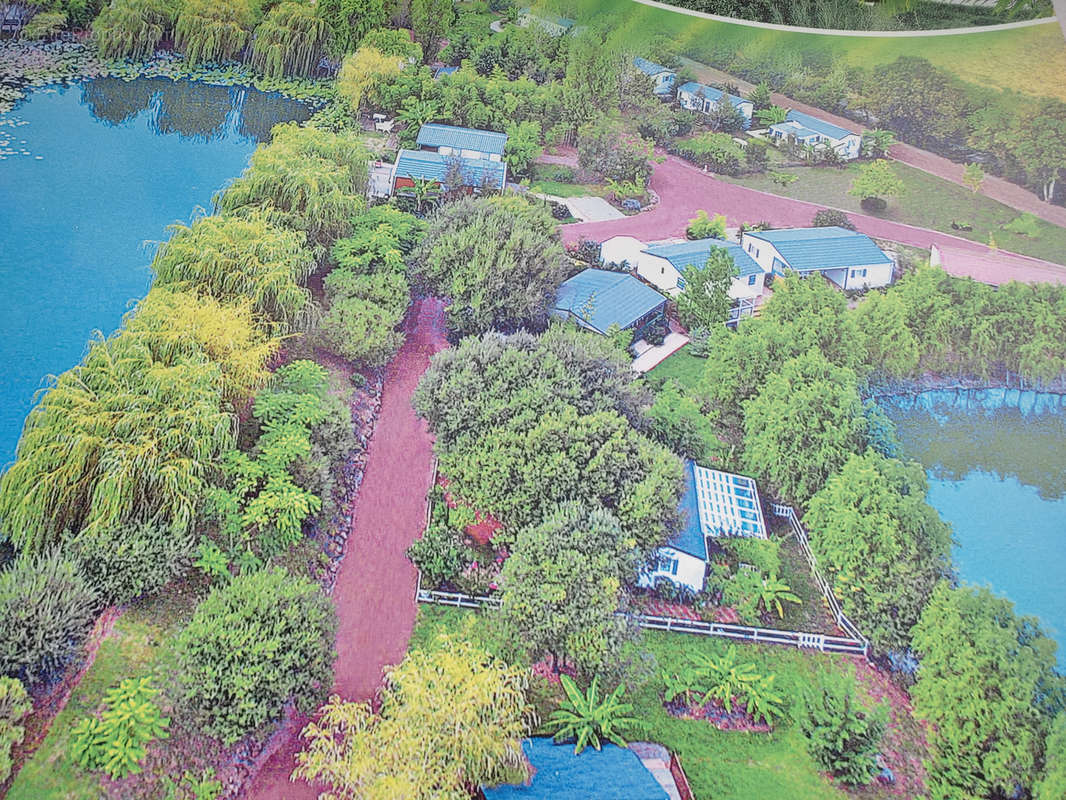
top-left (682, 59), bottom-right (1066, 227)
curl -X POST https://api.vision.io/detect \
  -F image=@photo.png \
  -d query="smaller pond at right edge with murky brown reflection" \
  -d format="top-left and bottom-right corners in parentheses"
top-left (881, 389), bottom-right (1066, 646)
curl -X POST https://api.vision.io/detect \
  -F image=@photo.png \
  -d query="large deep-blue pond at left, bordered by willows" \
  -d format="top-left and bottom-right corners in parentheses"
top-left (0, 78), bottom-right (310, 462)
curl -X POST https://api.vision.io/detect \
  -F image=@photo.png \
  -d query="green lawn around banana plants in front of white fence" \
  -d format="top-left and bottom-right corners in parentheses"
top-left (410, 606), bottom-right (892, 800)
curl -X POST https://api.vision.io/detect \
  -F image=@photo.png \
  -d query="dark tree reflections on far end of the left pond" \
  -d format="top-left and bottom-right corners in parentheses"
top-left (81, 78), bottom-right (310, 142)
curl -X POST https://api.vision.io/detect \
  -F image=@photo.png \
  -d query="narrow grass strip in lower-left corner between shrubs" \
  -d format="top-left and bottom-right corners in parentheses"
top-left (7, 591), bottom-right (200, 800)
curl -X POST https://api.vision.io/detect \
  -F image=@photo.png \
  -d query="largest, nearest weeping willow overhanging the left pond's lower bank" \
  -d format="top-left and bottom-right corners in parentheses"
top-left (0, 298), bottom-right (236, 551)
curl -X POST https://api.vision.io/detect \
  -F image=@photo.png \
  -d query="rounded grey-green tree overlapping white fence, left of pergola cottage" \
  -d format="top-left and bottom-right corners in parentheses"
top-left (500, 502), bottom-right (636, 674)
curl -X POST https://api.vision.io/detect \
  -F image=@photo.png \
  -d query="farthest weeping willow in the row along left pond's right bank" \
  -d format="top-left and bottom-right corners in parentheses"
top-left (215, 123), bottom-right (369, 246)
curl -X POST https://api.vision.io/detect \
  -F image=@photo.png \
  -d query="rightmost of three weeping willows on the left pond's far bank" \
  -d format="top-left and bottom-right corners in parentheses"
top-left (252, 2), bottom-right (329, 78)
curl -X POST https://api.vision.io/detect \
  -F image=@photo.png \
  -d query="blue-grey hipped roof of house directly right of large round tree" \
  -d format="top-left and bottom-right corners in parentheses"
top-left (555, 269), bottom-right (666, 333)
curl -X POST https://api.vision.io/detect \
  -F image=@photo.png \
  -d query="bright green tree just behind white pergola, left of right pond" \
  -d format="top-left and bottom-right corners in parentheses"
top-left (743, 350), bottom-right (866, 505)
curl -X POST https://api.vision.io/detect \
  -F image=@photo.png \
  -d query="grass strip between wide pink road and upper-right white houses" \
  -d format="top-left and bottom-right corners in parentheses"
top-left (709, 162), bottom-right (1066, 263)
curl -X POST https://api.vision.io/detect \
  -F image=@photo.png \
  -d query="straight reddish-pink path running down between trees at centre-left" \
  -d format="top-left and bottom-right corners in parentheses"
top-left (245, 298), bottom-right (448, 800)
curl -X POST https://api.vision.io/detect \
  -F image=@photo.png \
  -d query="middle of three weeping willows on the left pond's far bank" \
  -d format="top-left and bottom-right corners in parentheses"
top-left (174, 0), bottom-right (255, 66)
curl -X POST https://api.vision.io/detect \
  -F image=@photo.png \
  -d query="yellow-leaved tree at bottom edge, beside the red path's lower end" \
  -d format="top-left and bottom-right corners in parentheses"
top-left (295, 636), bottom-right (534, 800)
